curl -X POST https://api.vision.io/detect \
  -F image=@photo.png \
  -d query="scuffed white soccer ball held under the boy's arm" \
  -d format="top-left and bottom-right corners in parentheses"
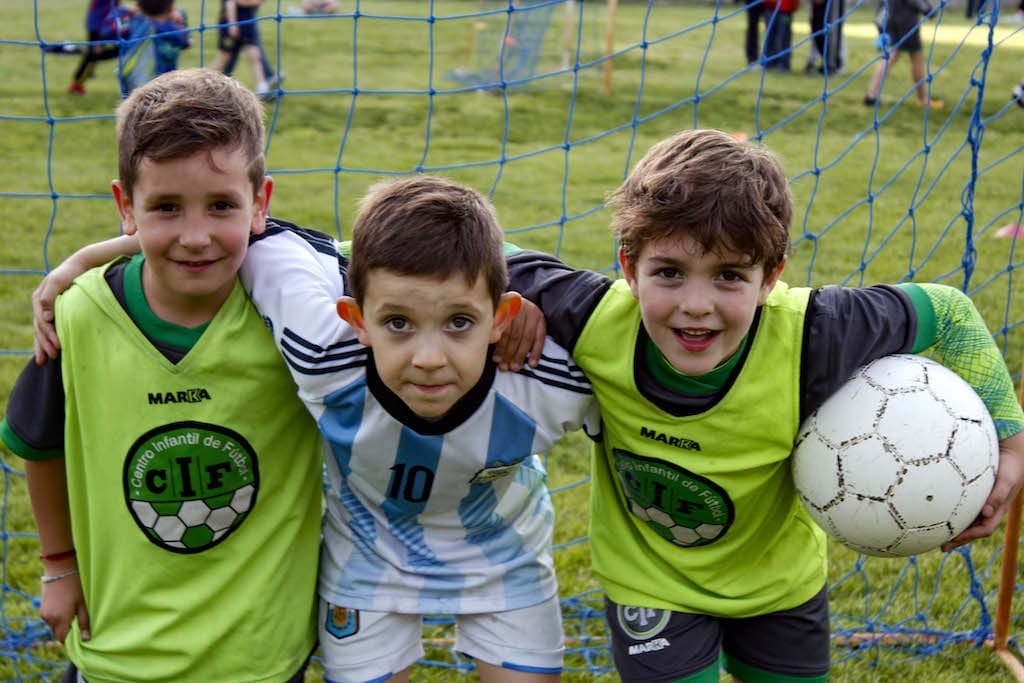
top-left (792, 355), bottom-right (999, 557)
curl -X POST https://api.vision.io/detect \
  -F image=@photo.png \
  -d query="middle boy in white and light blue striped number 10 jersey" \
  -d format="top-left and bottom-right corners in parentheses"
top-left (36, 176), bottom-right (599, 683)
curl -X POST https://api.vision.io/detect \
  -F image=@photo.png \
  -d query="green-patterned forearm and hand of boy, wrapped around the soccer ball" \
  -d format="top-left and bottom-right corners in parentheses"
top-left (919, 284), bottom-right (1024, 550)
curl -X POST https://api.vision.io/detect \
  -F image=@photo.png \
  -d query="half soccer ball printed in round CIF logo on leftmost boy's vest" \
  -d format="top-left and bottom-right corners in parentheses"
top-left (131, 484), bottom-right (256, 553)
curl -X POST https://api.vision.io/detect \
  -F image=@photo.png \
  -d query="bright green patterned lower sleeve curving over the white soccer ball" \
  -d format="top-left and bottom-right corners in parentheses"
top-left (899, 283), bottom-right (1024, 440)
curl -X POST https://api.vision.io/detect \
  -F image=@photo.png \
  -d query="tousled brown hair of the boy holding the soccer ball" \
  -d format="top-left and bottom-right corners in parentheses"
top-left (608, 130), bottom-right (793, 272)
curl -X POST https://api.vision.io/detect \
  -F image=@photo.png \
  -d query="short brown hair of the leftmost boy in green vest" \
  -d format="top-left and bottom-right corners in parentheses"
top-left (118, 69), bottom-right (266, 198)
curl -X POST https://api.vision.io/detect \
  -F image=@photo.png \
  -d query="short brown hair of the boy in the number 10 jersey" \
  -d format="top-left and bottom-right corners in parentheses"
top-left (348, 175), bottom-right (508, 306)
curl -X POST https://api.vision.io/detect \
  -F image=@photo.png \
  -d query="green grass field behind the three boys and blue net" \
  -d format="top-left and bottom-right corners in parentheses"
top-left (0, 0), bottom-right (1024, 683)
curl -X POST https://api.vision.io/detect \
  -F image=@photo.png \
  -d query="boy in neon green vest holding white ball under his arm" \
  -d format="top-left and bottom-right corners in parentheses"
top-left (495, 130), bottom-right (1024, 683)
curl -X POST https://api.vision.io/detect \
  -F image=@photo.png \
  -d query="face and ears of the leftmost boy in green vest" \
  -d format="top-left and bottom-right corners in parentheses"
top-left (114, 148), bottom-right (272, 327)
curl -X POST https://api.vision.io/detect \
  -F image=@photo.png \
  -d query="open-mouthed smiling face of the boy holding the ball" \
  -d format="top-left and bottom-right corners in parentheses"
top-left (621, 237), bottom-right (782, 376)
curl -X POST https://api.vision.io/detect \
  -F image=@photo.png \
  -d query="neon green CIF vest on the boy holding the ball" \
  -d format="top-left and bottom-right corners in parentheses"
top-left (572, 281), bottom-right (826, 617)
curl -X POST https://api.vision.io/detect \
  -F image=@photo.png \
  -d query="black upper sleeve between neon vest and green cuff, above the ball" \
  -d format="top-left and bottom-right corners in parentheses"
top-left (800, 285), bottom-right (918, 422)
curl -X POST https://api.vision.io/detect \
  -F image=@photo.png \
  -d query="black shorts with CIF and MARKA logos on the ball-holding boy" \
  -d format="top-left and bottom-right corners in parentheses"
top-left (604, 587), bottom-right (831, 683)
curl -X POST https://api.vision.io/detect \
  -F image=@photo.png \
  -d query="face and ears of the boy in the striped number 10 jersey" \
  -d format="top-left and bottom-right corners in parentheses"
top-left (338, 269), bottom-right (519, 420)
